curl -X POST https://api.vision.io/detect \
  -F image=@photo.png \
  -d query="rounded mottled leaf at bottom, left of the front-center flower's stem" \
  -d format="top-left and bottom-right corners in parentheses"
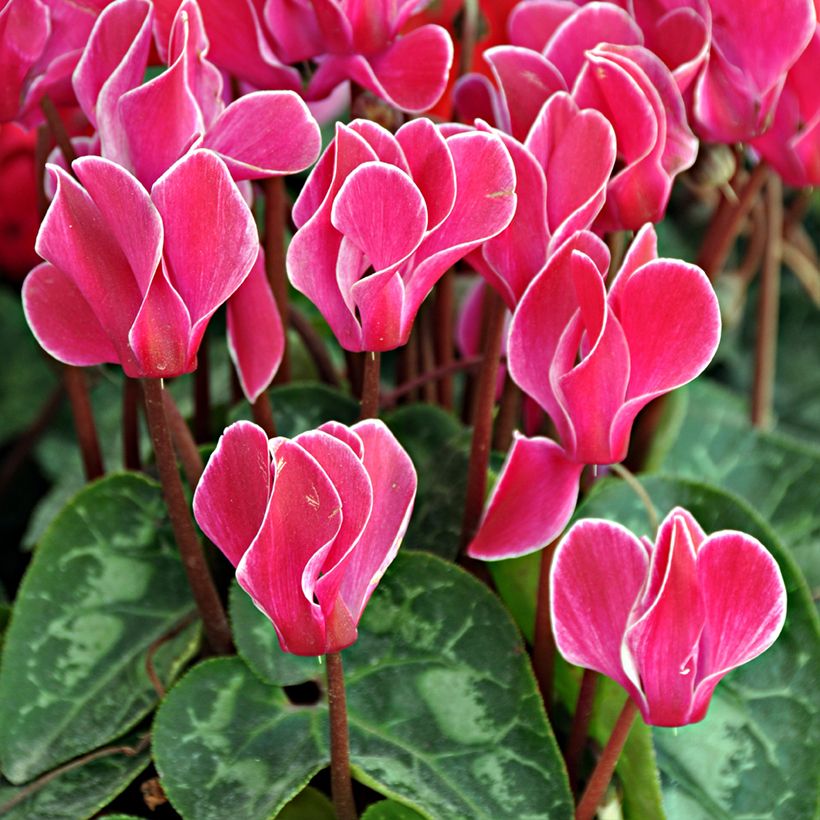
top-left (153, 658), bottom-right (328, 820)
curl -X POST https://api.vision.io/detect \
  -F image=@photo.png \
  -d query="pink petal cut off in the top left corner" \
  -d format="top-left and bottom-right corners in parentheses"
top-left (0, 0), bottom-right (51, 122)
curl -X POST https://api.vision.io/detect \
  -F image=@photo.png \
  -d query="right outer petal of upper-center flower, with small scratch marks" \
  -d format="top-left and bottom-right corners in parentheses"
top-left (406, 131), bottom-right (517, 314)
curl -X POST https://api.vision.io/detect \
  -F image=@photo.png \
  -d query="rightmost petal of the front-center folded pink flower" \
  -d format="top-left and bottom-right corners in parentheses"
top-left (332, 419), bottom-right (418, 623)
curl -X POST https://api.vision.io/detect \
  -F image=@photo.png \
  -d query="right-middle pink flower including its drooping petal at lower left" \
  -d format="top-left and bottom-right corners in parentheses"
top-left (468, 225), bottom-right (720, 560)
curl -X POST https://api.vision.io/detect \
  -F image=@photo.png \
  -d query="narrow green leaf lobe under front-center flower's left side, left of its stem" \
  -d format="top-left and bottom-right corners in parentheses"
top-left (230, 582), bottom-right (325, 686)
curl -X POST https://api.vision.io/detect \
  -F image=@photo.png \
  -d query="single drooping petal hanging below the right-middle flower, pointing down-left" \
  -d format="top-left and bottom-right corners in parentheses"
top-left (467, 433), bottom-right (588, 560)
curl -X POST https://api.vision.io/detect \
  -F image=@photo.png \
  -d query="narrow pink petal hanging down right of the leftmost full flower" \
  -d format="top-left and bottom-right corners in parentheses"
top-left (228, 248), bottom-right (285, 402)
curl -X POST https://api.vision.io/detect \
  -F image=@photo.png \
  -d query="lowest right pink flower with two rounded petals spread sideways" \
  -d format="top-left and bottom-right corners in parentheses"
top-left (550, 507), bottom-right (786, 726)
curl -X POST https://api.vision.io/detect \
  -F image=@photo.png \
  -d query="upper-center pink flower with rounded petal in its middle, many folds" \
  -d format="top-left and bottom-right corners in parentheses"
top-left (287, 119), bottom-right (516, 351)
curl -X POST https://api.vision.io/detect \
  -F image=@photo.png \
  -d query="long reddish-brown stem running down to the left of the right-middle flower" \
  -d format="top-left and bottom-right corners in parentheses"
top-left (461, 288), bottom-right (506, 550)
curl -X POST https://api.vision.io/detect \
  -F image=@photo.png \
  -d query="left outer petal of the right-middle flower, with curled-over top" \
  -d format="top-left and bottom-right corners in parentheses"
top-left (507, 231), bottom-right (609, 430)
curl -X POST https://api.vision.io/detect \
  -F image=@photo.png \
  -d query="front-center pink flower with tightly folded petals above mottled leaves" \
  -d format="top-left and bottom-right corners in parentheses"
top-left (194, 419), bottom-right (416, 655)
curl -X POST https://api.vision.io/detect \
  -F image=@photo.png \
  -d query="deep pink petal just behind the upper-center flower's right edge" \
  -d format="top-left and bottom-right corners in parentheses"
top-left (477, 121), bottom-right (549, 310)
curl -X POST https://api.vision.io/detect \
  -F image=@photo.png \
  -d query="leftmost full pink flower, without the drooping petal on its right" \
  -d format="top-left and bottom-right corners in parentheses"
top-left (23, 151), bottom-right (259, 378)
